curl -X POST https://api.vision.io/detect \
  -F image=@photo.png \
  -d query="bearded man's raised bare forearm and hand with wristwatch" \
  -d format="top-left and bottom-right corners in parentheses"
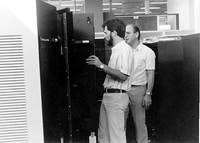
top-left (86, 55), bottom-right (128, 81)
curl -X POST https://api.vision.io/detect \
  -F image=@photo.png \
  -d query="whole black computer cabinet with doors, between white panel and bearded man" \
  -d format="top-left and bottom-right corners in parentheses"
top-left (37, 1), bottom-right (98, 142)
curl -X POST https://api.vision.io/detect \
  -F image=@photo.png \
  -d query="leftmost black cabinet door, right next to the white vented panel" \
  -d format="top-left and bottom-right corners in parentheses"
top-left (37, 0), bottom-right (67, 143)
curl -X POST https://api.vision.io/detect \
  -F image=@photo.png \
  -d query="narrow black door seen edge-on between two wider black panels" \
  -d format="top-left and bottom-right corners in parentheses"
top-left (57, 8), bottom-right (73, 143)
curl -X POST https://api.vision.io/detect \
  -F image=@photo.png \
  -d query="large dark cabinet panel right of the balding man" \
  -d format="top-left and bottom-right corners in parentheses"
top-left (153, 35), bottom-right (200, 143)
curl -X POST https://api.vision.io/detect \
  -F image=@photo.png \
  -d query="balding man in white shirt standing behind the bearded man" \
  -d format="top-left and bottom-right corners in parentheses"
top-left (125, 24), bottom-right (155, 143)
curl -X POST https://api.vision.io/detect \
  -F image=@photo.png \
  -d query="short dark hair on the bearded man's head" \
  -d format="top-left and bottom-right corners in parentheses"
top-left (102, 18), bottom-right (126, 38)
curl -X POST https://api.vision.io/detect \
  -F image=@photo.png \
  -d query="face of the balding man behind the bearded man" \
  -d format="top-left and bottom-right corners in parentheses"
top-left (125, 25), bottom-right (137, 44)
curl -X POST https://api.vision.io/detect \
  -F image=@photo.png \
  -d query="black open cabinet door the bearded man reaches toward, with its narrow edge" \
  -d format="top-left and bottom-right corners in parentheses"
top-left (58, 9), bottom-right (98, 143)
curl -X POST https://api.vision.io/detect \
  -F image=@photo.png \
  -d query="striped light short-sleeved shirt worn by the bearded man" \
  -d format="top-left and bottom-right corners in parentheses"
top-left (104, 41), bottom-right (133, 90)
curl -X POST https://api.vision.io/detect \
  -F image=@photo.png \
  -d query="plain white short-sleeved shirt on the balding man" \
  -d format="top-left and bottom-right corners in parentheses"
top-left (130, 43), bottom-right (156, 85)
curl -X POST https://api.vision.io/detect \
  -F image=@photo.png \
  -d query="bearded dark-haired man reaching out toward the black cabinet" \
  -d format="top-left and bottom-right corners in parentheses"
top-left (86, 19), bottom-right (133, 143)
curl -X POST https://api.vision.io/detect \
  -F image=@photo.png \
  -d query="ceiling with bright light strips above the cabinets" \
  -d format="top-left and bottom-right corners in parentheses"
top-left (43, 0), bottom-right (167, 15)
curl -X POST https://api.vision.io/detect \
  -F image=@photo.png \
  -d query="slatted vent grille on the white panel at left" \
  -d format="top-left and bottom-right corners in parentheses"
top-left (0, 35), bottom-right (28, 143)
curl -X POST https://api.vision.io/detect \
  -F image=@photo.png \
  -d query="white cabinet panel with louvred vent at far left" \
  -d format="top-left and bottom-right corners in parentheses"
top-left (0, 0), bottom-right (44, 143)
